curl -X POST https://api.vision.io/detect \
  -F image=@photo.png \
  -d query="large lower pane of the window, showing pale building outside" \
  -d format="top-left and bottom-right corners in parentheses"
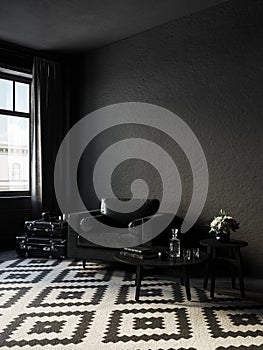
top-left (0, 115), bottom-right (29, 191)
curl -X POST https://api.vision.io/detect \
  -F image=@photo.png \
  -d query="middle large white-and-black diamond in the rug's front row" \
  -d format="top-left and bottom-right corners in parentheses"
top-left (103, 307), bottom-right (192, 343)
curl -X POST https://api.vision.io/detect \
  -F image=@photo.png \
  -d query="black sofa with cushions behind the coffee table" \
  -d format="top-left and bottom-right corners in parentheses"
top-left (68, 198), bottom-right (182, 267)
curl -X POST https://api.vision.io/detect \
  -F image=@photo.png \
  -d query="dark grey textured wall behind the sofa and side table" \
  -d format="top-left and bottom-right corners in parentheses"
top-left (72, 0), bottom-right (263, 276)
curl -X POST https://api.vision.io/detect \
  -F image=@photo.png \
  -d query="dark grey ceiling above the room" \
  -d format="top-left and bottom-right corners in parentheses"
top-left (0, 0), bottom-right (228, 51)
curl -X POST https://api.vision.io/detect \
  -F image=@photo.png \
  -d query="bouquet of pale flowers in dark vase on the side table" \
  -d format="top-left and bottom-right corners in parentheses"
top-left (209, 209), bottom-right (239, 242)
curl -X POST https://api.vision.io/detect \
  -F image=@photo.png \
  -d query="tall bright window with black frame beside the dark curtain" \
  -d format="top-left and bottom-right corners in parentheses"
top-left (0, 68), bottom-right (31, 195)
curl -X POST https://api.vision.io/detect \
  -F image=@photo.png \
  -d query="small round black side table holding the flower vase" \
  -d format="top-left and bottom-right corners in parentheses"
top-left (200, 239), bottom-right (248, 298)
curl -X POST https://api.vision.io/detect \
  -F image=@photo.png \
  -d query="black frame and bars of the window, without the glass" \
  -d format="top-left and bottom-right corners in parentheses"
top-left (0, 70), bottom-right (32, 198)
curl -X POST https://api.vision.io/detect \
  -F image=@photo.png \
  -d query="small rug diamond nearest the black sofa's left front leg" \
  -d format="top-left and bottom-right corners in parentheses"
top-left (53, 266), bottom-right (113, 283)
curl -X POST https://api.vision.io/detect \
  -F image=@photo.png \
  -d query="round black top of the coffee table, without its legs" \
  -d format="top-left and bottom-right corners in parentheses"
top-left (114, 247), bottom-right (208, 268)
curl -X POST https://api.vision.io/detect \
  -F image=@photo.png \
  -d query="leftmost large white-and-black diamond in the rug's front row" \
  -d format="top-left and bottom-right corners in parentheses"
top-left (0, 311), bottom-right (95, 347)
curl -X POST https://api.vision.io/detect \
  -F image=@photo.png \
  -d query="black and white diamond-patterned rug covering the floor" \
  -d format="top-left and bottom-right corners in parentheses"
top-left (0, 259), bottom-right (263, 350)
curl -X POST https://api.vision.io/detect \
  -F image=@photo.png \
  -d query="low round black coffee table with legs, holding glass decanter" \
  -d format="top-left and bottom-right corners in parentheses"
top-left (114, 250), bottom-right (207, 301)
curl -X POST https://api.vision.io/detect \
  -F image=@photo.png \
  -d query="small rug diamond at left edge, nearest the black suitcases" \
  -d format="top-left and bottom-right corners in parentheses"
top-left (0, 269), bottom-right (52, 284)
